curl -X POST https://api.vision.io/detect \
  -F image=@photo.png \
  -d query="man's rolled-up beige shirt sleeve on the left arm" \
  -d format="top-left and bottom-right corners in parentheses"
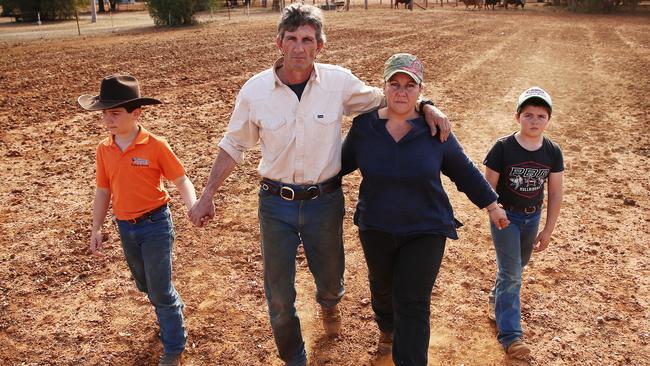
top-left (218, 91), bottom-right (259, 164)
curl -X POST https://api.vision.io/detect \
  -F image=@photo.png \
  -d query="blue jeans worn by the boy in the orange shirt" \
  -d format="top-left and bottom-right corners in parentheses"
top-left (116, 208), bottom-right (187, 354)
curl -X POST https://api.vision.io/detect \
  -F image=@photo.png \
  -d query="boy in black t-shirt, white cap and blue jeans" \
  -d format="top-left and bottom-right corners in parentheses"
top-left (483, 87), bottom-right (564, 358)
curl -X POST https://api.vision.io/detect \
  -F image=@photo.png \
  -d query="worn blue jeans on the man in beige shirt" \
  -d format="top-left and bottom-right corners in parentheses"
top-left (259, 188), bottom-right (345, 365)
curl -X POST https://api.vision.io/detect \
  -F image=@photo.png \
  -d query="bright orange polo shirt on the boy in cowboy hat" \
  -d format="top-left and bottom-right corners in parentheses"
top-left (96, 126), bottom-right (185, 220)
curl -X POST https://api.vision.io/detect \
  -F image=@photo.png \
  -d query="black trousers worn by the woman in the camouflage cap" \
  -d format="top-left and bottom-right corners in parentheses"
top-left (359, 230), bottom-right (447, 366)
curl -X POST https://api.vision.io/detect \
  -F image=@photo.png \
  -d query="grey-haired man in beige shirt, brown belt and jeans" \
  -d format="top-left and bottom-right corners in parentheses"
top-left (190, 3), bottom-right (449, 365)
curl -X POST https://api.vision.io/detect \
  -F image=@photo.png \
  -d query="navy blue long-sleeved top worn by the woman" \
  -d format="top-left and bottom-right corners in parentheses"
top-left (341, 110), bottom-right (497, 239)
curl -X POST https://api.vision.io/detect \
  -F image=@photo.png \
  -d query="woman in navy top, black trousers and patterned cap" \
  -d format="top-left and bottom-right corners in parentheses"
top-left (341, 53), bottom-right (508, 365)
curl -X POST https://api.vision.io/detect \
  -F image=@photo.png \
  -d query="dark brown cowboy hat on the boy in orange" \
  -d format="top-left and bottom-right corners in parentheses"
top-left (77, 74), bottom-right (162, 111)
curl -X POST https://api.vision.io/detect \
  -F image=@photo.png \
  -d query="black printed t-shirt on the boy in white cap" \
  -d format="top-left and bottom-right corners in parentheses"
top-left (483, 134), bottom-right (564, 207)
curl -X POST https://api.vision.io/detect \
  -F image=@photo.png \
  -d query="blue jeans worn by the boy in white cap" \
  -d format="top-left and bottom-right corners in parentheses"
top-left (490, 211), bottom-right (541, 349)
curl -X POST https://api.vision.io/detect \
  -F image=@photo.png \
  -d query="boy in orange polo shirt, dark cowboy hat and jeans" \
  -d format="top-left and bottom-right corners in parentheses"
top-left (78, 75), bottom-right (196, 365)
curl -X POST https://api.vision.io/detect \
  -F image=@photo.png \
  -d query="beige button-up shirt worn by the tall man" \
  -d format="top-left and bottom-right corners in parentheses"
top-left (219, 59), bottom-right (383, 184)
